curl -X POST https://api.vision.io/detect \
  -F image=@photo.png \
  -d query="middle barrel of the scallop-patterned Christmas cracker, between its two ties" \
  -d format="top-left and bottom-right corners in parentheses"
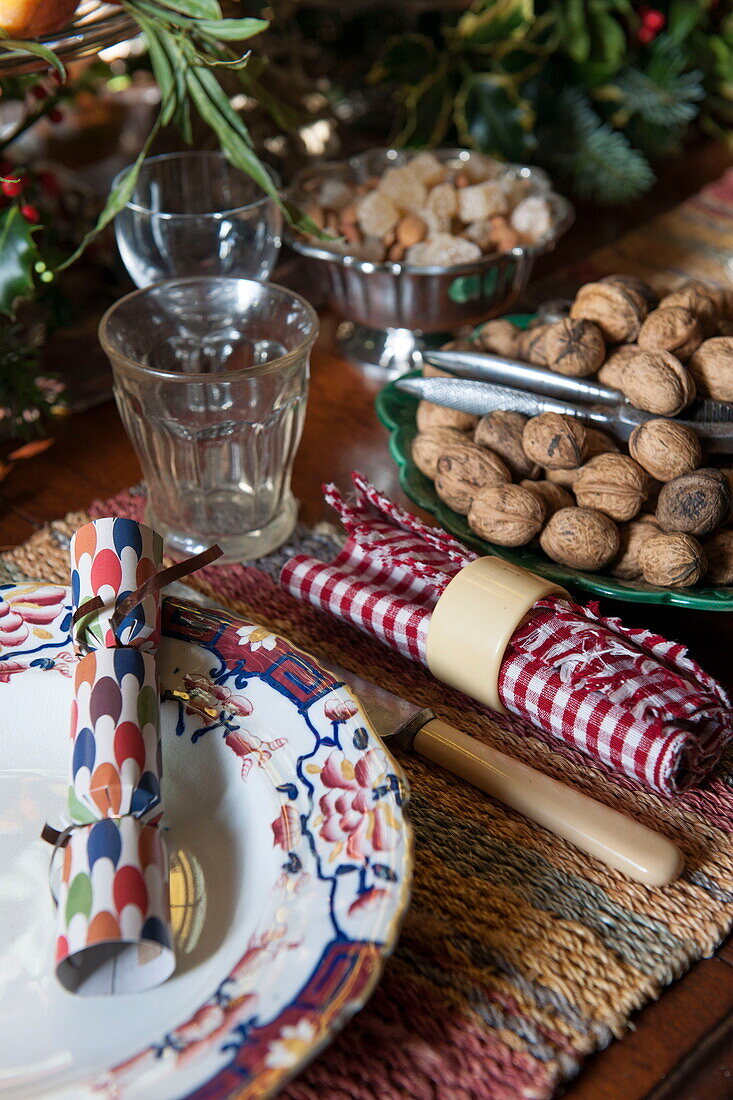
top-left (68, 648), bottom-right (161, 824)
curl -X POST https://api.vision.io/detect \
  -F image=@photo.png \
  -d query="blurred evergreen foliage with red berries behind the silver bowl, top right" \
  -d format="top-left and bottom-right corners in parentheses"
top-left (371, 0), bottom-right (733, 202)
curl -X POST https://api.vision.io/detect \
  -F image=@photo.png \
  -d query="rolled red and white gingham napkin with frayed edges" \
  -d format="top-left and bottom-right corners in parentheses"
top-left (281, 474), bottom-right (732, 794)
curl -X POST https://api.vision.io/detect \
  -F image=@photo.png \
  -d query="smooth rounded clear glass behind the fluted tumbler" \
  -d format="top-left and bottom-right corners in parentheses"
top-left (112, 152), bottom-right (283, 287)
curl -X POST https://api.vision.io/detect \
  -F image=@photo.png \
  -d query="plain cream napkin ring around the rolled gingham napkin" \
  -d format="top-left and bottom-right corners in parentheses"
top-left (427, 557), bottom-right (570, 714)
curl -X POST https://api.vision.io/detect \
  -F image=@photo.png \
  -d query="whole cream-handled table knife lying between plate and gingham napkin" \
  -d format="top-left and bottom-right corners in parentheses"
top-left (321, 659), bottom-right (683, 887)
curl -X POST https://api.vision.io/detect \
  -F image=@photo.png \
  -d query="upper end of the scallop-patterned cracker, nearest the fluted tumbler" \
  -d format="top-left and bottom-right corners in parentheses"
top-left (70, 517), bottom-right (163, 653)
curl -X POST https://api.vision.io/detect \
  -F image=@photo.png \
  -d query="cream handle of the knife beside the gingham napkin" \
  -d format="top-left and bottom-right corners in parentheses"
top-left (413, 718), bottom-right (683, 887)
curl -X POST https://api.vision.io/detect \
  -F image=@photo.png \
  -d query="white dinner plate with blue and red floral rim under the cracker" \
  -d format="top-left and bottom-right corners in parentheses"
top-left (0, 584), bottom-right (412, 1100)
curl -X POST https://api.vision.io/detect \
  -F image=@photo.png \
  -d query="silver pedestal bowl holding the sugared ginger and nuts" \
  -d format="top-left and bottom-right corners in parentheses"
top-left (287, 149), bottom-right (573, 376)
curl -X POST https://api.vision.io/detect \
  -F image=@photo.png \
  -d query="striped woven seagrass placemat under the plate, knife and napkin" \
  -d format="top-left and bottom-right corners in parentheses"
top-left (0, 491), bottom-right (733, 1100)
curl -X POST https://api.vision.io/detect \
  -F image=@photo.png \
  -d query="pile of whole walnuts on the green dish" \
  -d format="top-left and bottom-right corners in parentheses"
top-left (413, 276), bottom-right (733, 589)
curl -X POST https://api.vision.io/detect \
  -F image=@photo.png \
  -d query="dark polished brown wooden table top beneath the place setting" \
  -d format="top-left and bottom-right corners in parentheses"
top-left (0, 146), bottom-right (733, 1100)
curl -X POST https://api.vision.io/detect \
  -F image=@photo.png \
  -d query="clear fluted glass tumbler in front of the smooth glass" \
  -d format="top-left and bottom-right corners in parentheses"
top-left (99, 278), bottom-right (318, 562)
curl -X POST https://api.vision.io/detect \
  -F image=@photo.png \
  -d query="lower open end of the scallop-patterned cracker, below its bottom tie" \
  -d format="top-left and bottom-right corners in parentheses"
top-left (56, 816), bottom-right (175, 997)
